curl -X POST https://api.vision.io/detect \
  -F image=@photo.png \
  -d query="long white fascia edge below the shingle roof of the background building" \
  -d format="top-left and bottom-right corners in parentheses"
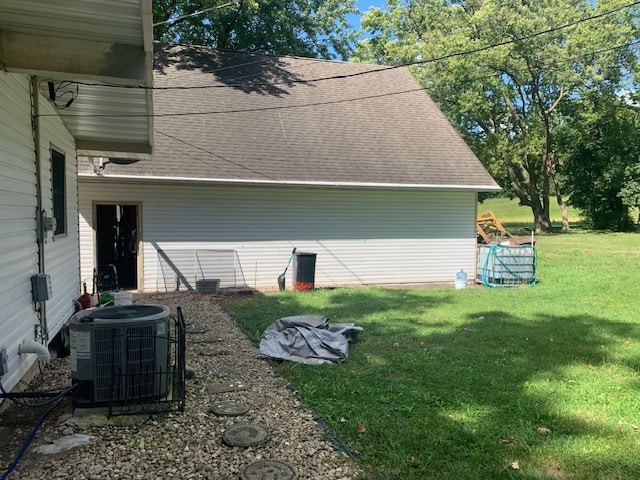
top-left (78, 173), bottom-right (502, 192)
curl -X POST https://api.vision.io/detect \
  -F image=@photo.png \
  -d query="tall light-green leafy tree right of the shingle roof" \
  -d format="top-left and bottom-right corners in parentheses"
top-left (356, 0), bottom-right (637, 232)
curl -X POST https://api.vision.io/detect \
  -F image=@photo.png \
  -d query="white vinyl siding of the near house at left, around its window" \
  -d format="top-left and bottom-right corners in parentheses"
top-left (0, 72), bottom-right (78, 394)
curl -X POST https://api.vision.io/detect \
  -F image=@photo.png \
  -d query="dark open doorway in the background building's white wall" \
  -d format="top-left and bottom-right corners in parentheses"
top-left (96, 205), bottom-right (138, 290)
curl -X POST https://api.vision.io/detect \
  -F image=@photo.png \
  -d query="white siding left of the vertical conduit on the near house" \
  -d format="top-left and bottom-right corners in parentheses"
top-left (0, 72), bottom-right (38, 388)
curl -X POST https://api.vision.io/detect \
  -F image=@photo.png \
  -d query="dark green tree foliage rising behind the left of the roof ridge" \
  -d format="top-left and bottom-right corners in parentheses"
top-left (153, 0), bottom-right (357, 58)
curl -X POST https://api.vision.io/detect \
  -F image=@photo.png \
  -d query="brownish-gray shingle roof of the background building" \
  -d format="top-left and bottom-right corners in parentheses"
top-left (95, 44), bottom-right (497, 189)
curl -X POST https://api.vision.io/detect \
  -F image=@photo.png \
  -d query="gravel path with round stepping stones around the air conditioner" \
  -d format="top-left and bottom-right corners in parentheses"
top-left (0, 293), bottom-right (360, 480)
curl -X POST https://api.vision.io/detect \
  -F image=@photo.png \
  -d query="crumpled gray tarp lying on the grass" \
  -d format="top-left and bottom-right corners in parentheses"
top-left (259, 315), bottom-right (364, 365)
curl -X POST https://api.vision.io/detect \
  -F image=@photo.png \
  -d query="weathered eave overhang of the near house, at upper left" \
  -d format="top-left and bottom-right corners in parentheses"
top-left (0, 0), bottom-right (153, 154)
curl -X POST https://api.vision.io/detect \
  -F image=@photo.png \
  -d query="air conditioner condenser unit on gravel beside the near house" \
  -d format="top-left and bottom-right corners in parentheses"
top-left (69, 305), bottom-right (172, 408)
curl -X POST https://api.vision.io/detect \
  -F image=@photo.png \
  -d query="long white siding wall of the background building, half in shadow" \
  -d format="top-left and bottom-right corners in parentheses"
top-left (80, 177), bottom-right (476, 291)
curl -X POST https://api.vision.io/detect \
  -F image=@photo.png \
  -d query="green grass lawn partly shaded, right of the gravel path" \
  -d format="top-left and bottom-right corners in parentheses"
top-left (226, 200), bottom-right (640, 480)
